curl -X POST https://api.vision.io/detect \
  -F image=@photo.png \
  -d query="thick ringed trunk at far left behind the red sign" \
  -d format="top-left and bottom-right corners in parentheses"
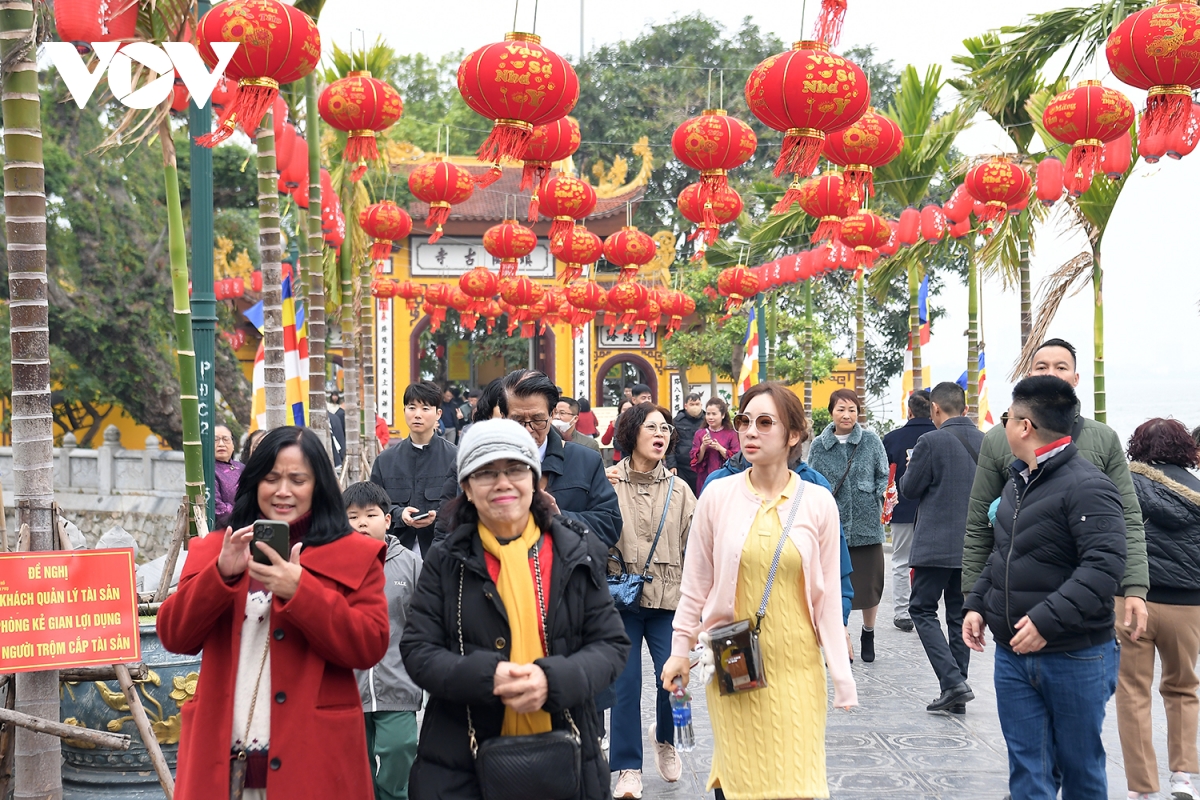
top-left (0, 0), bottom-right (62, 800)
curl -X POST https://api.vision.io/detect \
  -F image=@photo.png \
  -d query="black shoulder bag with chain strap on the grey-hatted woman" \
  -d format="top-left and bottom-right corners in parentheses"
top-left (458, 549), bottom-right (581, 800)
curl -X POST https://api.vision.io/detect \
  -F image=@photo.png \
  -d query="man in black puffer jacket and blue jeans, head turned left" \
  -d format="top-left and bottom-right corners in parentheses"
top-left (962, 375), bottom-right (1126, 800)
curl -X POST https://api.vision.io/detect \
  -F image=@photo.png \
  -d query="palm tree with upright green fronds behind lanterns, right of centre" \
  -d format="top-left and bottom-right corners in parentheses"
top-left (870, 65), bottom-right (974, 390)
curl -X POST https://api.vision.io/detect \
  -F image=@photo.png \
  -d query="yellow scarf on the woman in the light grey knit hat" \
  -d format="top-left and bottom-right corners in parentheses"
top-left (479, 515), bottom-right (551, 736)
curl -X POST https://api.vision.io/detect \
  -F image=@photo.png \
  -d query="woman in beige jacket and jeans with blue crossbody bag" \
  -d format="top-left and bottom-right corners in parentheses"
top-left (608, 403), bottom-right (696, 800)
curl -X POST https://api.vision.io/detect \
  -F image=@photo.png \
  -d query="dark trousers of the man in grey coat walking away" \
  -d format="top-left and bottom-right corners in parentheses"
top-left (908, 566), bottom-right (971, 692)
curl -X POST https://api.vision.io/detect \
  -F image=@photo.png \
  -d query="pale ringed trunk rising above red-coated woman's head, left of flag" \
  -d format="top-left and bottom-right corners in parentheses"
top-left (256, 112), bottom-right (285, 431)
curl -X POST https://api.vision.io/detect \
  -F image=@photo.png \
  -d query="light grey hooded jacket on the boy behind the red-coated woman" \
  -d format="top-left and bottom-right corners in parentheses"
top-left (354, 534), bottom-right (421, 711)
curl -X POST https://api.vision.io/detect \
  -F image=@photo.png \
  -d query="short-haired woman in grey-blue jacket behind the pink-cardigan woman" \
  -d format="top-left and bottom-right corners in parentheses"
top-left (809, 389), bottom-right (888, 663)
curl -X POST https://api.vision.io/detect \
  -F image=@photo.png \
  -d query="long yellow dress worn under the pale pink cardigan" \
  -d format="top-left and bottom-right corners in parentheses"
top-left (707, 473), bottom-right (829, 800)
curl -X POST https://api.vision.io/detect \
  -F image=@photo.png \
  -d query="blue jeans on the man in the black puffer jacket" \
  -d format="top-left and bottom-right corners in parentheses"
top-left (995, 640), bottom-right (1121, 800)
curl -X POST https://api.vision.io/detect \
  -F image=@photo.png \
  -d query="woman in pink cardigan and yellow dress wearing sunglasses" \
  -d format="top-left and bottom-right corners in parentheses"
top-left (662, 383), bottom-right (858, 800)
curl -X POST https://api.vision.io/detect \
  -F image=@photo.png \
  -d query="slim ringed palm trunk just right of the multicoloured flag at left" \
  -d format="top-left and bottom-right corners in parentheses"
top-left (304, 73), bottom-right (334, 459)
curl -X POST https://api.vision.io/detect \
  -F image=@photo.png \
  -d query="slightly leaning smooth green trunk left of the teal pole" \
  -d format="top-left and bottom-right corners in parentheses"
top-left (158, 119), bottom-right (206, 537)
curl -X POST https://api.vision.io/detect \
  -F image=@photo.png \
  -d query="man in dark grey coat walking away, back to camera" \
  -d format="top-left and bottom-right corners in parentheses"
top-left (898, 383), bottom-right (983, 714)
